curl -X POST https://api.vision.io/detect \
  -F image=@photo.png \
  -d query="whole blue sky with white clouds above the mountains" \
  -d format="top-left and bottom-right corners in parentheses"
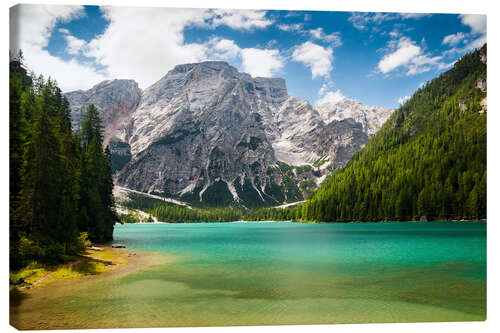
top-left (10, 5), bottom-right (486, 108)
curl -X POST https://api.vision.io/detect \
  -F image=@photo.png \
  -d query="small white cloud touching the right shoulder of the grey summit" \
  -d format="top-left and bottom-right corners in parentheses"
top-left (240, 48), bottom-right (284, 77)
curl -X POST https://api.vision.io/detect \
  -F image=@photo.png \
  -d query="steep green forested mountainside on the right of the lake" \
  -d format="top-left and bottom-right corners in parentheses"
top-left (296, 45), bottom-right (487, 221)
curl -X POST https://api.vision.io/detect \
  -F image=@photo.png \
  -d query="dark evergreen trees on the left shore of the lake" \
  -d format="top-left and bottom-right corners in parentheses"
top-left (9, 52), bottom-right (118, 269)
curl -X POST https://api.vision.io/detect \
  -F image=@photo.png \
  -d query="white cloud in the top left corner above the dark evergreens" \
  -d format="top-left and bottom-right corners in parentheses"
top-left (10, 5), bottom-right (107, 91)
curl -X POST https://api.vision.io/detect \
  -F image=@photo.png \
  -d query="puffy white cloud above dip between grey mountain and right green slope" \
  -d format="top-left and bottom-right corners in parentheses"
top-left (377, 37), bottom-right (449, 76)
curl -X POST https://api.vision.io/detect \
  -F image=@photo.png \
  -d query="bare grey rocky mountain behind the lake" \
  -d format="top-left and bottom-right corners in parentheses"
top-left (66, 61), bottom-right (392, 207)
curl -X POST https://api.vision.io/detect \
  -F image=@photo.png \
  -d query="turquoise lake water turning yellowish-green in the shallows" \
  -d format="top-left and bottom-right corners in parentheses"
top-left (10, 222), bottom-right (486, 328)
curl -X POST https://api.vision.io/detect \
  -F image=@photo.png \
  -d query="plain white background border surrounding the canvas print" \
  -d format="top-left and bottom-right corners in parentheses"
top-left (0, 0), bottom-right (500, 333)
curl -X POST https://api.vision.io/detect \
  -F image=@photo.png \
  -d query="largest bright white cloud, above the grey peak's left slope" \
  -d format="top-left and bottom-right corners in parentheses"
top-left (85, 7), bottom-right (207, 88)
